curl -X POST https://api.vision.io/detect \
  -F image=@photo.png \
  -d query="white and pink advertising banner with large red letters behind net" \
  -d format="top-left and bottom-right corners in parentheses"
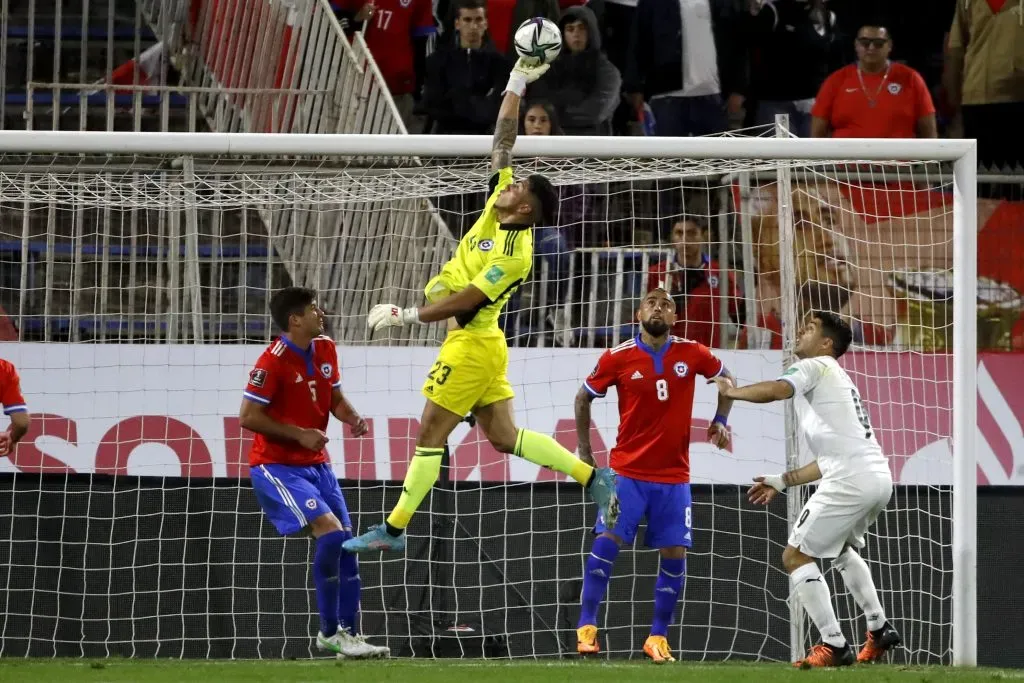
top-left (0, 344), bottom-right (1024, 485)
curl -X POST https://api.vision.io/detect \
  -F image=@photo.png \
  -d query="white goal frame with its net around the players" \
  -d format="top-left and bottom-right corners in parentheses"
top-left (0, 131), bottom-right (978, 666)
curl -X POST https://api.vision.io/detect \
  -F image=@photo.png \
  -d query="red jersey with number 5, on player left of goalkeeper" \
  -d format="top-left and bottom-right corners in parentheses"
top-left (243, 337), bottom-right (341, 467)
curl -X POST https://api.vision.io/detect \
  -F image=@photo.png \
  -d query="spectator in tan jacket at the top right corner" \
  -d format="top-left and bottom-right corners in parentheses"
top-left (945, 0), bottom-right (1024, 167)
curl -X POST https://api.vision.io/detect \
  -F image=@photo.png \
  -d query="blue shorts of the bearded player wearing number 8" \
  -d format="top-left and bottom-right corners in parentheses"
top-left (594, 474), bottom-right (693, 548)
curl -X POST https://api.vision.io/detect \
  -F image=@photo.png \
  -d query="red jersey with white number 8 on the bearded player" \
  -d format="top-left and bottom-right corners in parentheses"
top-left (584, 336), bottom-right (725, 483)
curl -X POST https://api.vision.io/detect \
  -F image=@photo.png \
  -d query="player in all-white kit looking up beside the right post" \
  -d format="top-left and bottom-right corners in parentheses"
top-left (712, 311), bottom-right (900, 668)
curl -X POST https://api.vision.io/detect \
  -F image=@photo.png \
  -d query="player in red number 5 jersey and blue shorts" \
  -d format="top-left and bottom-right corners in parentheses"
top-left (240, 287), bottom-right (389, 657)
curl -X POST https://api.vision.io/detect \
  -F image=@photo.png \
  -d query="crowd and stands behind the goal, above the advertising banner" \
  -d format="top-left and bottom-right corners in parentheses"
top-left (0, 0), bottom-right (1024, 350)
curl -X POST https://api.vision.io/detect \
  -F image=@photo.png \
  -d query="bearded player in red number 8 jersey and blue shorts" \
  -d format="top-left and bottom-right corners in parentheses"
top-left (575, 289), bottom-right (732, 664)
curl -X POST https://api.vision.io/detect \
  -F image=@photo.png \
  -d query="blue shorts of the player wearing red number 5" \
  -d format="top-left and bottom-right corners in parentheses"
top-left (249, 463), bottom-right (352, 536)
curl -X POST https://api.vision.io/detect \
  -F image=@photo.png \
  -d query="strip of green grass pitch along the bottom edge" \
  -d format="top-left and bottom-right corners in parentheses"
top-left (0, 659), bottom-right (1024, 683)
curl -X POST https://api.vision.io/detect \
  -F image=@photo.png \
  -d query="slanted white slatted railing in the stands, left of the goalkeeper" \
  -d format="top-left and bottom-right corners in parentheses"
top-left (137, 0), bottom-right (451, 341)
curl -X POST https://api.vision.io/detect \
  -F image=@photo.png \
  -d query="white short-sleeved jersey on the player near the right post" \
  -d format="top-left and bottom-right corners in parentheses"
top-left (778, 355), bottom-right (890, 482)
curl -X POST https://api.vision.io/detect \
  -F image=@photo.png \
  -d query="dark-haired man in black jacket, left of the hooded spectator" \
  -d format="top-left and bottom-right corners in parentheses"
top-left (423, 0), bottom-right (511, 135)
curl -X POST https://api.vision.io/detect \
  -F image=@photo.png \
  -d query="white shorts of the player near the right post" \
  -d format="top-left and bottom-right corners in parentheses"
top-left (788, 474), bottom-right (893, 559)
